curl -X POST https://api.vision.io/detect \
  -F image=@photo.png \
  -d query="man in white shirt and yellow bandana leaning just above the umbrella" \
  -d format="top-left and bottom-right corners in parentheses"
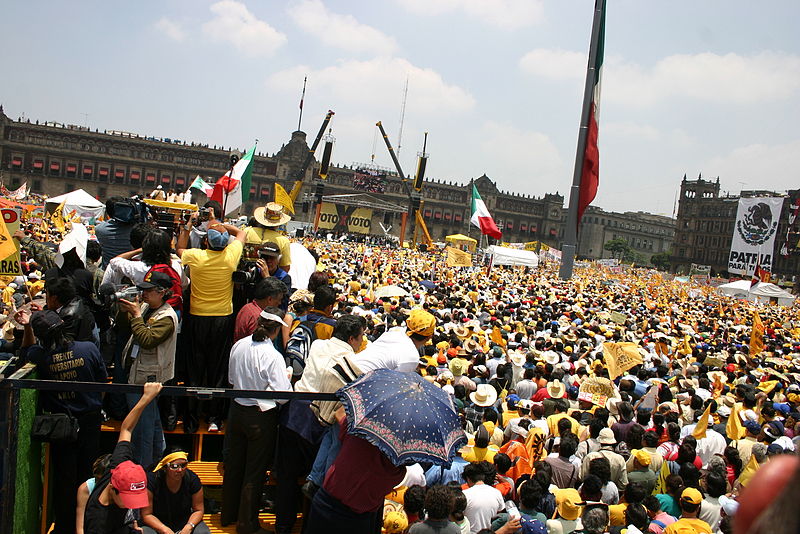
top-left (353, 309), bottom-right (436, 373)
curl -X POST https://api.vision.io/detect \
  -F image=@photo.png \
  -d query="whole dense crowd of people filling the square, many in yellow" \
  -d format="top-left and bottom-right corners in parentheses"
top-left (0, 198), bottom-right (800, 534)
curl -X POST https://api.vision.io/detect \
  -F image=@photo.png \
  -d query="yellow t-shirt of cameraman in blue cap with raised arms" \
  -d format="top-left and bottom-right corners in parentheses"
top-left (181, 241), bottom-right (244, 317)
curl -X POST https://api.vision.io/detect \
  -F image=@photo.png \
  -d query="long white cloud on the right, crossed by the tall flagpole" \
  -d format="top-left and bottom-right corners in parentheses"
top-left (520, 48), bottom-right (800, 107)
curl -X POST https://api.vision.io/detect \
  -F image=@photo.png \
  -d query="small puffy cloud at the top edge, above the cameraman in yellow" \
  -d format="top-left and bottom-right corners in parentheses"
top-left (203, 0), bottom-right (286, 57)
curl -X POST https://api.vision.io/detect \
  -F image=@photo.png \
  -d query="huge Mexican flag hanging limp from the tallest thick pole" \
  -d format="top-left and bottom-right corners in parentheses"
top-left (578, 3), bottom-right (606, 224)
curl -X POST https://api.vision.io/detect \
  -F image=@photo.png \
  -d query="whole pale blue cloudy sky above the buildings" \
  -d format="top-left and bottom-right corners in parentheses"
top-left (0, 0), bottom-right (800, 214)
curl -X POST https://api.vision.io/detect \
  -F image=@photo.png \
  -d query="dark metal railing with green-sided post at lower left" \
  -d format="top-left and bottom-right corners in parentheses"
top-left (0, 360), bottom-right (337, 534)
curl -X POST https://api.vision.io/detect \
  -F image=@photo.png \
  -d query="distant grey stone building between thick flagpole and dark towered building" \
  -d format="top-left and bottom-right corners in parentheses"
top-left (577, 206), bottom-right (675, 263)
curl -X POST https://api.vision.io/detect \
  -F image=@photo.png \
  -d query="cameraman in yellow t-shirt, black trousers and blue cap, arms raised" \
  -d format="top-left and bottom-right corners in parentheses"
top-left (177, 210), bottom-right (245, 433)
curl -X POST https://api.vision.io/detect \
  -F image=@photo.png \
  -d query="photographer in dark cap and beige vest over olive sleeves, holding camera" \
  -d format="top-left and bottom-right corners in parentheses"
top-left (119, 271), bottom-right (178, 472)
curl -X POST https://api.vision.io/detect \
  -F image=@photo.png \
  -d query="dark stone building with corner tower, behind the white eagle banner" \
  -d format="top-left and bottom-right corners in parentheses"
top-left (671, 175), bottom-right (800, 280)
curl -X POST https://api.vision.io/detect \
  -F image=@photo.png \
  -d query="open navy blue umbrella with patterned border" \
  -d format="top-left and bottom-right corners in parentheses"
top-left (336, 369), bottom-right (467, 465)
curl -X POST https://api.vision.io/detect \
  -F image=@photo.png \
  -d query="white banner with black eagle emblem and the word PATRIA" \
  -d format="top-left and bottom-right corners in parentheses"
top-left (728, 197), bottom-right (783, 276)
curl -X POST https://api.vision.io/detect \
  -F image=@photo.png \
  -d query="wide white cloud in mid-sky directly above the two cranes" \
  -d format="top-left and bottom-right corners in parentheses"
top-left (267, 57), bottom-right (475, 116)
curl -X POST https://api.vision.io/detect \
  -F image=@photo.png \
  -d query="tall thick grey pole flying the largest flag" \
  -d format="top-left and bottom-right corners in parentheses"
top-left (558, 0), bottom-right (605, 280)
